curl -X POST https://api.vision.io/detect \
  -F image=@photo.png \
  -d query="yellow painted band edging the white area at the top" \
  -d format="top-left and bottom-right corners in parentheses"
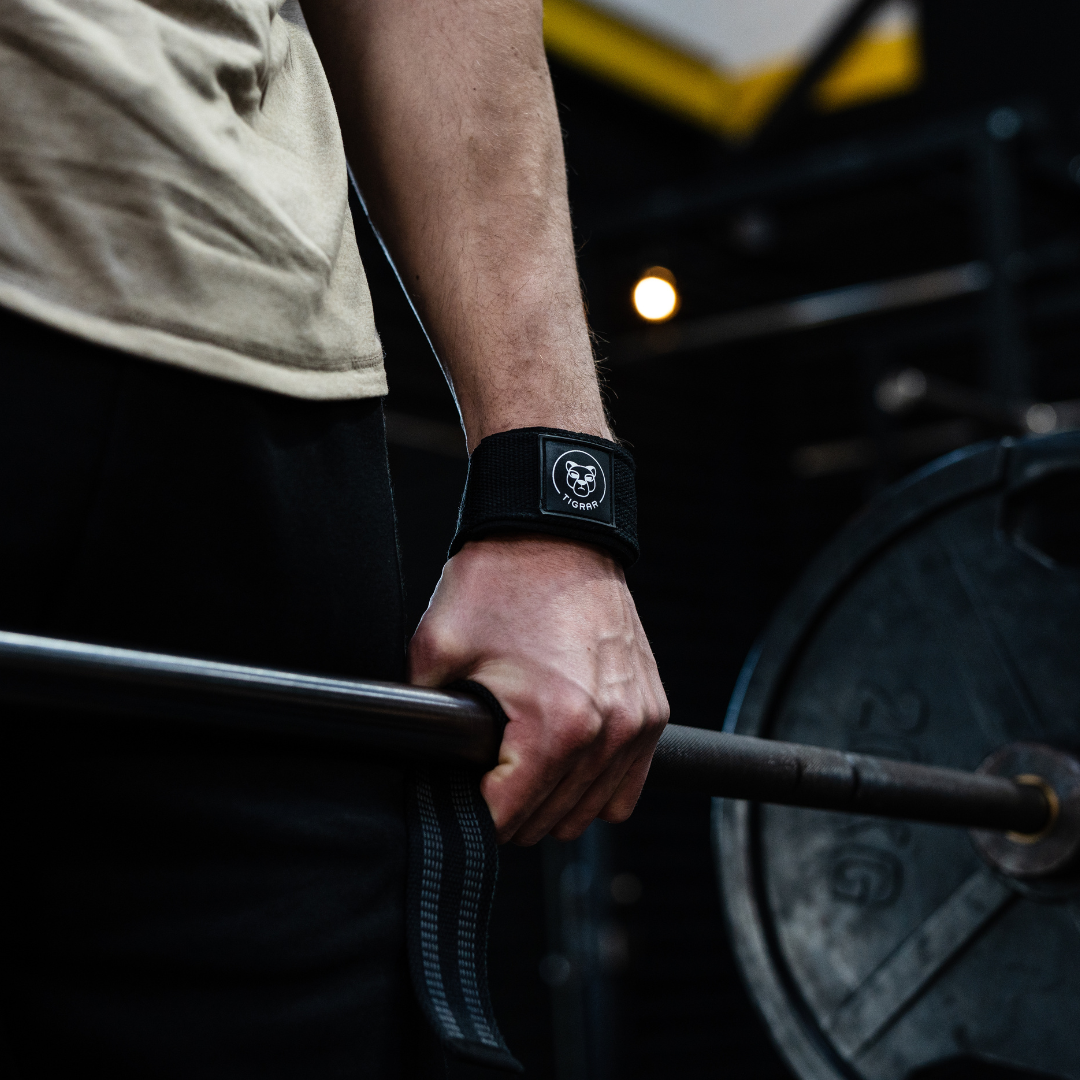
top-left (544, 0), bottom-right (921, 139)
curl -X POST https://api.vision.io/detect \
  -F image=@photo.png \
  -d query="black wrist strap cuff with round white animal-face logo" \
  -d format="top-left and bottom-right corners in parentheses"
top-left (449, 428), bottom-right (638, 566)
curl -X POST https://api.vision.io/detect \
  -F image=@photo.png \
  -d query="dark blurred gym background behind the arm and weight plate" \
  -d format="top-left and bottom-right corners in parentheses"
top-left (359, 0), bottom-right (1080, 1080)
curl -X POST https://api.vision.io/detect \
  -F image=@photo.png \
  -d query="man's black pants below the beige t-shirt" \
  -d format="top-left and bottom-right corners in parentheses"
top-left (0, 313), bottom-right (411, 1080)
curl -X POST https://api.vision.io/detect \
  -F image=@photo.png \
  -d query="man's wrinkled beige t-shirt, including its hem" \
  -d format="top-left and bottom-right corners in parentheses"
top-left (0, 0), bottom-right (387, 399)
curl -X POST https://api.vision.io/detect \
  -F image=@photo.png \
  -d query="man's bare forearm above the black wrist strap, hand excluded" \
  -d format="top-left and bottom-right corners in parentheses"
top-left (303, 0), bottom-right (610, 449)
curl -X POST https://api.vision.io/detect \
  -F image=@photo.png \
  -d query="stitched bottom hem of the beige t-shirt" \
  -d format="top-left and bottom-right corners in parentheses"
top-left (0, 282), bottom-right (388, 401)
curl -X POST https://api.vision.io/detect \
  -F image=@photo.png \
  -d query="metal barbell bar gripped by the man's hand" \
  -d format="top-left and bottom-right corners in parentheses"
top-left (0, 632), bottom-right (1050, 834)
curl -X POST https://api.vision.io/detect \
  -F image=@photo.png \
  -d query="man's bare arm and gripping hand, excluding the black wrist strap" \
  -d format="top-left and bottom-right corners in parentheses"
top-left (303, 0), bottom-right (667, 843)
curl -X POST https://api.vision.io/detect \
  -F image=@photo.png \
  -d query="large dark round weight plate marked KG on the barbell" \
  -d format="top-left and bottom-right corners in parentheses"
top-left (714, 433), bottom-right (1080, 1080)
